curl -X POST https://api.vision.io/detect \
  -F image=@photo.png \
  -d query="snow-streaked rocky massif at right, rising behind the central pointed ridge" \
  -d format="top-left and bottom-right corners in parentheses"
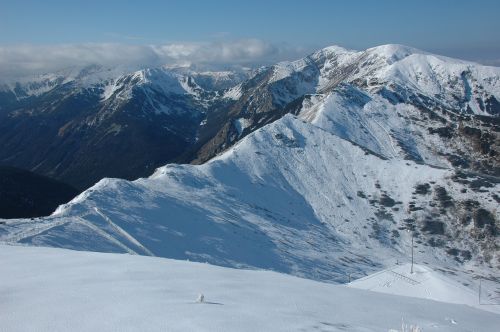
top-left (193, 45), bottom-right (500, 175)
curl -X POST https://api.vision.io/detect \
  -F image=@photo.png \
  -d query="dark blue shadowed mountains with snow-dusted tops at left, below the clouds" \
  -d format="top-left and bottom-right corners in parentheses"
top-left (0, 66), bottom-right (250, 189)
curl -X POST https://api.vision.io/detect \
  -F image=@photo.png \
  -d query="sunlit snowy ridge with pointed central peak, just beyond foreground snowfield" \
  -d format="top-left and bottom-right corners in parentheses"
top-left (0, 115), bottom-right (499, 282)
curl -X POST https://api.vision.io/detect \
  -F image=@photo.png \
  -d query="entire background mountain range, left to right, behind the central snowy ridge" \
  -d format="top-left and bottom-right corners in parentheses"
top-left (0, 45), bottom-right (500, 189)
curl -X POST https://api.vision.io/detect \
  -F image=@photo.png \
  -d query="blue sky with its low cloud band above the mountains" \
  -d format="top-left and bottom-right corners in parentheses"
top-left (0, 0), bottom-right (500, 77)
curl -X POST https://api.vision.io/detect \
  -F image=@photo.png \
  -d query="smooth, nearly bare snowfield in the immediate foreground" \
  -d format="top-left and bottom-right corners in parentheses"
top-left (0, 246), bottom-right (500, 332)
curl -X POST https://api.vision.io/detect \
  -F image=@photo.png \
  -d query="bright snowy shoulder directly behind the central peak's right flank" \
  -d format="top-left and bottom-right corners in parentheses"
top-left (299, 84), bottom-right (474, 168)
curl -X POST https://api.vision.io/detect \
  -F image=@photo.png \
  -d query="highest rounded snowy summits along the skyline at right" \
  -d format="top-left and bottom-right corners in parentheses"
top-left (270, 44), bottom-right (500, 115)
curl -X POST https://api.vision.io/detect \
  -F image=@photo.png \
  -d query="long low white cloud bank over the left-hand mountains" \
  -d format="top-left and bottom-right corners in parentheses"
top-left (0, 39), bottom-right (305, 80)
